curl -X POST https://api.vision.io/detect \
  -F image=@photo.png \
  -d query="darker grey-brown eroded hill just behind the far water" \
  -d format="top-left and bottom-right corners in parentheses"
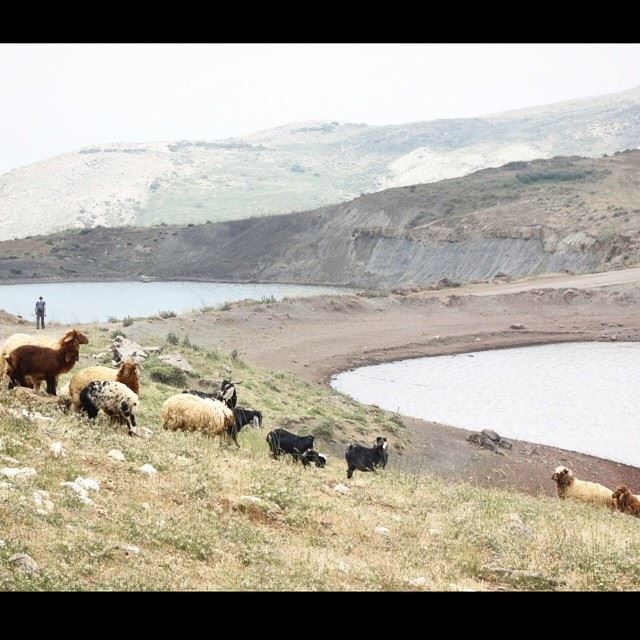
top-left (0, 151), bottom-right (640, 287)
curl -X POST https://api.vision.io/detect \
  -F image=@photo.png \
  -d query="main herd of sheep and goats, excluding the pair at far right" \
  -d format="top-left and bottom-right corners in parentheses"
top-left (0, 329), bottom-right (388, 478)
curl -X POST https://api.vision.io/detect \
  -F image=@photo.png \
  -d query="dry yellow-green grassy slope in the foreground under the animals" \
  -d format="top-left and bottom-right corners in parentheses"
top-left (0, 330), bottom-right (640, 591)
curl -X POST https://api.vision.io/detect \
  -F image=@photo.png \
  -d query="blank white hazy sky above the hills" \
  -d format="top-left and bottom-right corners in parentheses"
top-left (0, 44), bottom-right (640, 173)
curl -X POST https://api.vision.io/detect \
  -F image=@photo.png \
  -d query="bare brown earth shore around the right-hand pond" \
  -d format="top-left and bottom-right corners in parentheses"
top-left (0, 272), bottom-right (640, 495)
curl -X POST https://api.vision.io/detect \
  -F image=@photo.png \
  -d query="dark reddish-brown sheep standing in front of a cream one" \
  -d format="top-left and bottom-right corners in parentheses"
top-left (5, 329), bottom-right (89, 396)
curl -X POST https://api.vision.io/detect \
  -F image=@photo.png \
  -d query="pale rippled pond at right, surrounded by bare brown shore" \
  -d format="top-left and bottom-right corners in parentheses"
top-left (332, 342), bottom-right (640, 467)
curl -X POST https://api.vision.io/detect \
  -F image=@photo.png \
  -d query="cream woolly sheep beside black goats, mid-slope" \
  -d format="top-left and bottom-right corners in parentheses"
top-left (162, 393), bottom-right (235, 439)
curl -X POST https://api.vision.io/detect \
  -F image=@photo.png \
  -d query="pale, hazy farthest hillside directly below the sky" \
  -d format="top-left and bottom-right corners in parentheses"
top-left (0, 88), bottom-right (640, 239)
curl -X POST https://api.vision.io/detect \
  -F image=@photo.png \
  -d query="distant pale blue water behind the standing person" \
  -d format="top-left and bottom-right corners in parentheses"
top-left (0, 282), bottom-right (352, 324)
